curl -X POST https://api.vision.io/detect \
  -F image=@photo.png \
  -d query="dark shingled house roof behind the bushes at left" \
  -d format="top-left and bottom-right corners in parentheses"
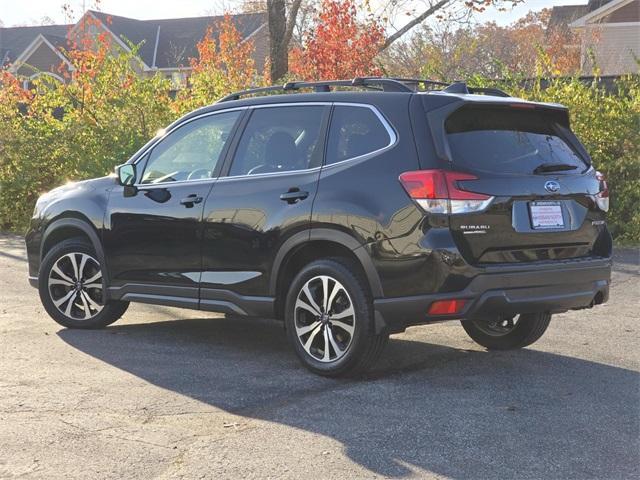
top-left (0, 10), bottom-right (267, 68)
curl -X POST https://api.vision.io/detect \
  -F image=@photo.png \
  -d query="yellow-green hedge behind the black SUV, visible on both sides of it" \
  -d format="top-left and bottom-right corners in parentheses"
top-left (0, 47), bottom-right (640, 244)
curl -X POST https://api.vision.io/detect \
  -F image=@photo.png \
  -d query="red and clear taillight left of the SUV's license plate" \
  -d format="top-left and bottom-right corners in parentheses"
top-left (400, 170), bottom-right (493, 214)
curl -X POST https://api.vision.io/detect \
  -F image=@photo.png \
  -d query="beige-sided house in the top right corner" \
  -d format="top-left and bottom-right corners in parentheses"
top-left (569, 0), bottom-right (640, 75)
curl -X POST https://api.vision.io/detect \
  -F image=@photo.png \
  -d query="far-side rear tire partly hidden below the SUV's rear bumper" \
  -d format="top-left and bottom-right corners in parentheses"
top-left (461, 313), bottom-right (551, 350)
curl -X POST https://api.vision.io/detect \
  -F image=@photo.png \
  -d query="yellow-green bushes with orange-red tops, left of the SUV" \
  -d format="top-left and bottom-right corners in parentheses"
top-left (0, 23), bottom-right (259, 232)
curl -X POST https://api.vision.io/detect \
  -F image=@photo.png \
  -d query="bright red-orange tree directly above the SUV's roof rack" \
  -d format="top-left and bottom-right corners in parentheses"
top-left (289, 0), bottom-right (384, 80)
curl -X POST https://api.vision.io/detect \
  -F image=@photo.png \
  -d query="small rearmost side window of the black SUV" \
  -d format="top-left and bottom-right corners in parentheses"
top-left (326, 105), bottom-right (391, 165)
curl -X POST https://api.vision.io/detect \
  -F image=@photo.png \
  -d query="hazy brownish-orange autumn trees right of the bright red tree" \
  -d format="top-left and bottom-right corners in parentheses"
top-left (383, 9), bottom-right (580, 81)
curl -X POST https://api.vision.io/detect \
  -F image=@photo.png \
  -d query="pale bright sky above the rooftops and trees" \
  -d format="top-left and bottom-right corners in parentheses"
top-left (0, 0), bottom-right (587, 27)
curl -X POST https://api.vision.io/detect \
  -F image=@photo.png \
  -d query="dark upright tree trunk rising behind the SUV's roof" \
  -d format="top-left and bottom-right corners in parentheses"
top-left (267, 0), bottom-right (302, 82)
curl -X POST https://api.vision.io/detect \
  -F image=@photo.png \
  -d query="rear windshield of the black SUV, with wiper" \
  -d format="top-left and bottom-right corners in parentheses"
top-left (445, 107), bottom-right (587, 174)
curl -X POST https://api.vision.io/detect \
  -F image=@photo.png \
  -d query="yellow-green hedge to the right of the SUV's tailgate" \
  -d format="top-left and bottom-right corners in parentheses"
top-left (474, 75), bottom-right (640, 244)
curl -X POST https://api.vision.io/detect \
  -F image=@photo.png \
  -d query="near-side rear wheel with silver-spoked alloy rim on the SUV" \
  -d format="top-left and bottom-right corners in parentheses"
top-left (285, 257), bottom-right (389, 377)
